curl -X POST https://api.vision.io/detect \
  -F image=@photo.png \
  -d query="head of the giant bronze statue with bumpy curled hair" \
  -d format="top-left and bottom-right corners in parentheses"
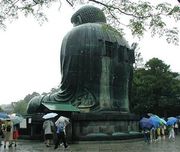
top-left (71, 5), bottom-right (106, 26)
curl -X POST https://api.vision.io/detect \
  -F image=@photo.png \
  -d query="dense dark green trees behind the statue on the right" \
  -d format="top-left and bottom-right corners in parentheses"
top-left (131, 58), bottom-right (180, 116)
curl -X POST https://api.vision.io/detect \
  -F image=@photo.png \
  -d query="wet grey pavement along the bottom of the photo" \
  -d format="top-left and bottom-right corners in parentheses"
top-left (0, 135), bottom-right (180, 152)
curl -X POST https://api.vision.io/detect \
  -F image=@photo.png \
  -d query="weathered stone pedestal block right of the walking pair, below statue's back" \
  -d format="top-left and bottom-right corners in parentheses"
top-left (72, 112), bottom-right (141, 141)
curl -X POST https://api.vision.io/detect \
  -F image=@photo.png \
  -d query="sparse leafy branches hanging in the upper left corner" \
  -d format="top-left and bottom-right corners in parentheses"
top-left (0, 0), bottom-right (57, 29)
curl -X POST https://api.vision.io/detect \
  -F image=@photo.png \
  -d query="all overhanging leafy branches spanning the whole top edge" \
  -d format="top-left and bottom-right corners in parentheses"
top-left (0, 0), bottom-right (180, 44)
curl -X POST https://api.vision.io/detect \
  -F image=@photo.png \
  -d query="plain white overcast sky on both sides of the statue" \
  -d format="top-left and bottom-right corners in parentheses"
top-left (0, 0), bottom-right (180, 104)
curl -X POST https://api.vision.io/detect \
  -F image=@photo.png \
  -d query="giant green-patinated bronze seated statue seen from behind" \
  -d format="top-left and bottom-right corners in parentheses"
top-left (28, 6), bottom-right (134, 113)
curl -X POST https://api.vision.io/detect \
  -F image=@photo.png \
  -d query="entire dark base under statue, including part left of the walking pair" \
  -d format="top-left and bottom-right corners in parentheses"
top-left (20, 111), bottom-right (143, 143)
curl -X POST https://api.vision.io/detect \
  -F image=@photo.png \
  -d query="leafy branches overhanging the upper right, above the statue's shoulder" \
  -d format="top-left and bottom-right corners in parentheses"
top-left (97, 0), bottom-right (180, 45)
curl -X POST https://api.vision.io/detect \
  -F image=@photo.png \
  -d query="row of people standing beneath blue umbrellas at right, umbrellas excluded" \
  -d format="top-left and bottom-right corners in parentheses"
top-left (143, 122), bottom-right (178, 143)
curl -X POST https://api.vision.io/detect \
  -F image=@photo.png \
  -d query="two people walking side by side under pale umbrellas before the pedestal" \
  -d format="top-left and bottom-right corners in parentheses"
top-left (43, 117), bottom-right (69, 149)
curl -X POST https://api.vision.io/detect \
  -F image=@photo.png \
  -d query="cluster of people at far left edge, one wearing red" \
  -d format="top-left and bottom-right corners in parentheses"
top-left (0, 119), bottom-right (19, 148)
